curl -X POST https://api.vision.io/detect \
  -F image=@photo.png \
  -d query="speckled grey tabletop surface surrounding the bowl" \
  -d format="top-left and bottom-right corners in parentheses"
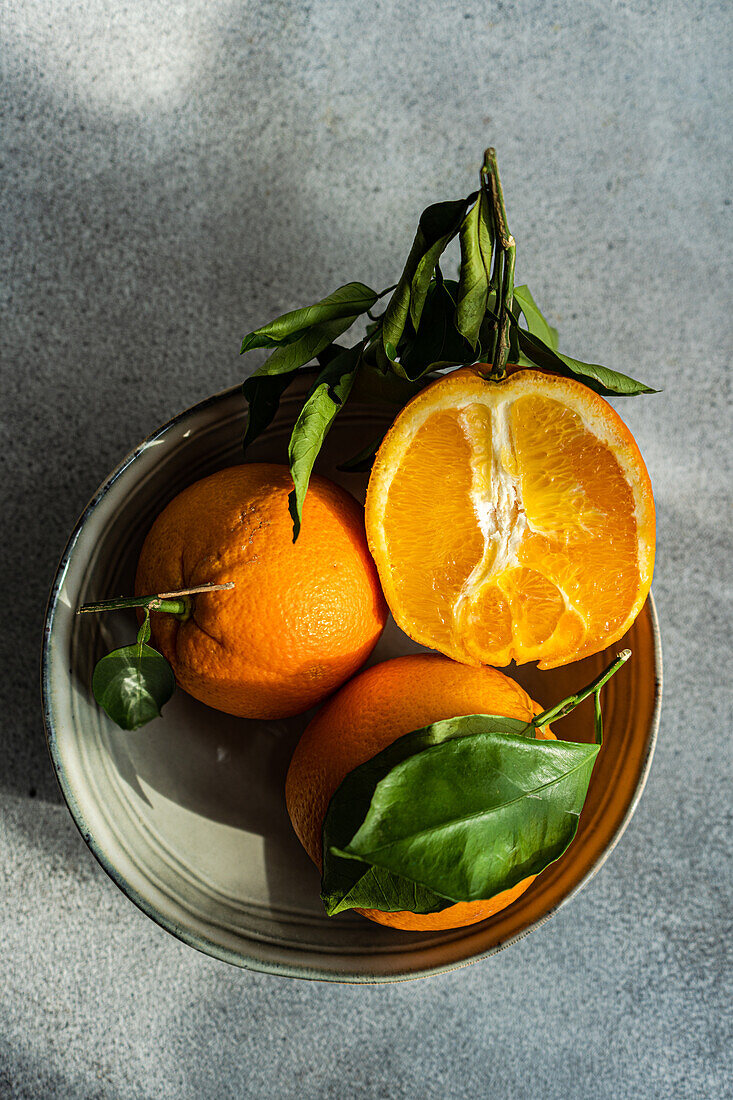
top-left (0, 0), bottom-right (733, 1100)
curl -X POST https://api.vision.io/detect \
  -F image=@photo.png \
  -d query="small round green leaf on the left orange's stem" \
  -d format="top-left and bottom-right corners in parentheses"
top-left (91, 613), bottom-right (176, 729)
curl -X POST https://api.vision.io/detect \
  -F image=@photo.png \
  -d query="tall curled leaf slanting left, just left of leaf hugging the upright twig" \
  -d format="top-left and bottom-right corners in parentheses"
top-left (382, 191), bottom-right (475, 367)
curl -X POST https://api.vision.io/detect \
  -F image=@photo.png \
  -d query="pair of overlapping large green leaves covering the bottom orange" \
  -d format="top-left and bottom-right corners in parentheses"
top-left (322, 715), bottom-right (599, 912)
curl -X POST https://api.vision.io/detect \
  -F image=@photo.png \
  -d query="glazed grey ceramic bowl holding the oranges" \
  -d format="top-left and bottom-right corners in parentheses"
top-left (43, 389), bottom-right (661, 982)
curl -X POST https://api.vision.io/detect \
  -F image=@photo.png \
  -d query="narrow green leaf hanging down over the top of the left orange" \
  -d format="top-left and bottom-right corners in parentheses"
top-left (287, 344), bottom-right (362, 542)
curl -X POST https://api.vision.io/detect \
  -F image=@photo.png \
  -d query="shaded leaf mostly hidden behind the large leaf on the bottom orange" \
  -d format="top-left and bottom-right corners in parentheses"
top-left (321, 715), bottom-right (548, 915)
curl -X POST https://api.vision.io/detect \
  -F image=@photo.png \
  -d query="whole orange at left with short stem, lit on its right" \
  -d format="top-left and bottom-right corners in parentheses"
top-left (135, 463), bottom-right (387, 719)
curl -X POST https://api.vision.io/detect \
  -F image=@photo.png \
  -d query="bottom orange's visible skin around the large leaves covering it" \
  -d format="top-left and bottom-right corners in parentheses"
top-left (285, 653), bottom-right (554, 932)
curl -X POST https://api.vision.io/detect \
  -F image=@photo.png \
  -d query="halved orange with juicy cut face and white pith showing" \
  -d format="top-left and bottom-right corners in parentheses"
top-left (367, 367), bottom-right (655, 669)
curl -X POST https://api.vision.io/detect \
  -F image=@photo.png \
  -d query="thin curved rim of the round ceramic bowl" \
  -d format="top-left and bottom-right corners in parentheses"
top-left (41, 386), bottom-right (664, 986)
